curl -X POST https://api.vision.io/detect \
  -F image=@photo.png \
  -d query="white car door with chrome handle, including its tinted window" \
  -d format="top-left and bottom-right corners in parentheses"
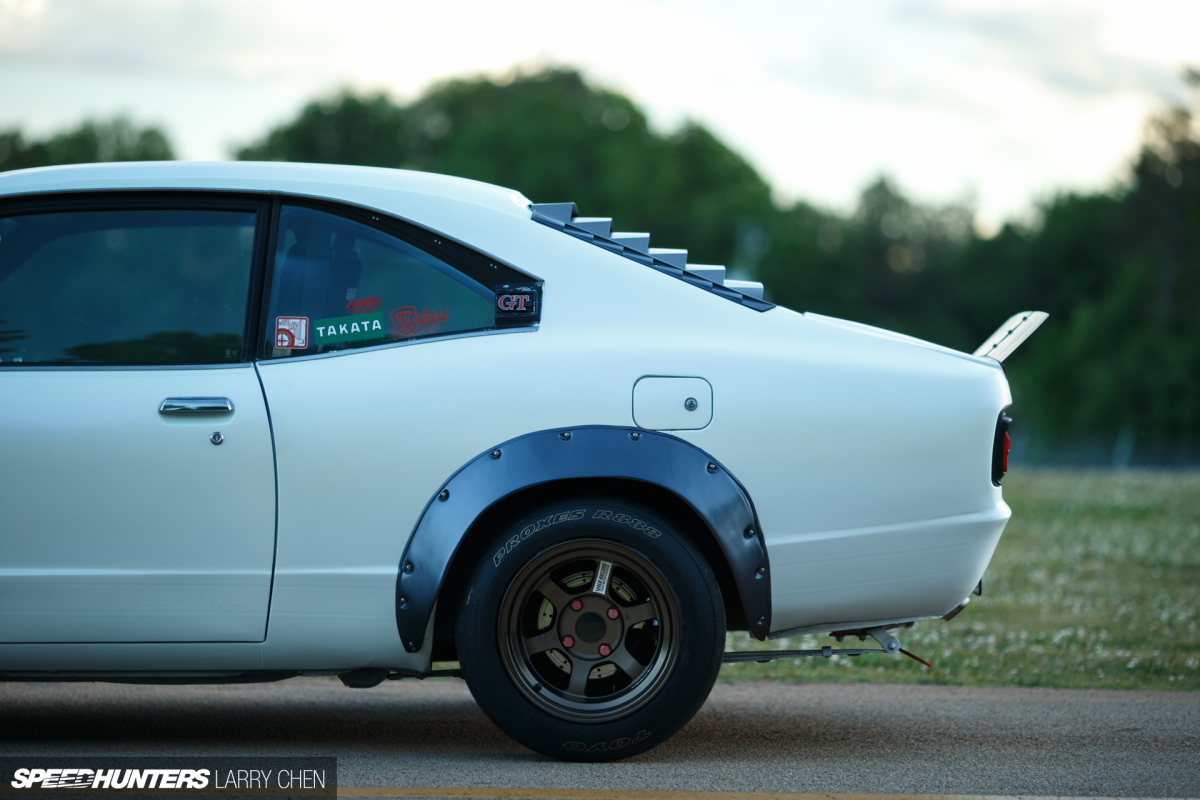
top-left (0, 199), bottom-right (275, 643)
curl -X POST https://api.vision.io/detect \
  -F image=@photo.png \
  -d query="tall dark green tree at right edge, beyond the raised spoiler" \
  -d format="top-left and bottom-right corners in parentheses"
top-left (1025, 90), bottom-right (1200, 439)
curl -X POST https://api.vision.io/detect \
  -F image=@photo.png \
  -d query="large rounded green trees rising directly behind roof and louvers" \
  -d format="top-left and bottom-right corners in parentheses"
top-left (235, 70), bottom-right (775, 263)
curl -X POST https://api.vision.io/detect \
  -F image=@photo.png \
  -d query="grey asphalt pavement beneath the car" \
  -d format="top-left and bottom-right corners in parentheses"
top-left (0, 679), bottom-right (1200, 798)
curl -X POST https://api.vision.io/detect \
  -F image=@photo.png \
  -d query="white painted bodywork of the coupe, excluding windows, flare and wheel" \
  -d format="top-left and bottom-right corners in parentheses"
top-left (0, 163), bottom-right (1027, 762)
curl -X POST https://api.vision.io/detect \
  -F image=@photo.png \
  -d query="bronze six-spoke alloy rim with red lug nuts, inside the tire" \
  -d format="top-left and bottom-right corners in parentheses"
top-left (497, 540), bottom-right (679, 722)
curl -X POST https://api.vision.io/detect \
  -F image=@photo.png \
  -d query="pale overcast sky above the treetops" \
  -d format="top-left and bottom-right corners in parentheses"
top-left (0, 0), bottom-right (1200, 229)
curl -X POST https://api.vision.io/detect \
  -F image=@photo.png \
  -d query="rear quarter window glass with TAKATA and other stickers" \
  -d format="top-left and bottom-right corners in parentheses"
top-left (268, 206), bottom-right (496, 357)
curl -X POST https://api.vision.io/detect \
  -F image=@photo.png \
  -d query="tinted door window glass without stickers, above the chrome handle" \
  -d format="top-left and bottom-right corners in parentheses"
top-left (0, 209), bottom-right (257, 366)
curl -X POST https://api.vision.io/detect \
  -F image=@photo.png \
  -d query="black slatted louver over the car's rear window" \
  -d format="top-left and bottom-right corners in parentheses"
top-left (529, 203), bottom-right (775, 311)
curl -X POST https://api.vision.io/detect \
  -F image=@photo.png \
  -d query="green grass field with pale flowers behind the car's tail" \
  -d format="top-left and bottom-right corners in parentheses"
top-left (721, 470), bottom-right (1200, 691)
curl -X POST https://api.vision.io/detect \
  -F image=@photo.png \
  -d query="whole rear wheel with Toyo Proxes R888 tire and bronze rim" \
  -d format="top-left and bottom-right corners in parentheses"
top-left (455, 498), bottom-right (725, 762)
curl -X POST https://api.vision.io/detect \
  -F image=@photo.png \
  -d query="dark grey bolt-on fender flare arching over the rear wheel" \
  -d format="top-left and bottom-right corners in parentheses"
top-left (396, 426), bottom-right (770, 652)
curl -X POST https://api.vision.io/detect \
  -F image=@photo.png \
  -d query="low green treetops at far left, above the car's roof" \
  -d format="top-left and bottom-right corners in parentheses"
top-left (0, 116), bottom-right (175, 172)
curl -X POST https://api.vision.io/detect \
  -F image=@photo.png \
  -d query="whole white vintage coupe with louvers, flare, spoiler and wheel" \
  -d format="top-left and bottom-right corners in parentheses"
top-left (0, 163), bottom-right (1044, 760)
